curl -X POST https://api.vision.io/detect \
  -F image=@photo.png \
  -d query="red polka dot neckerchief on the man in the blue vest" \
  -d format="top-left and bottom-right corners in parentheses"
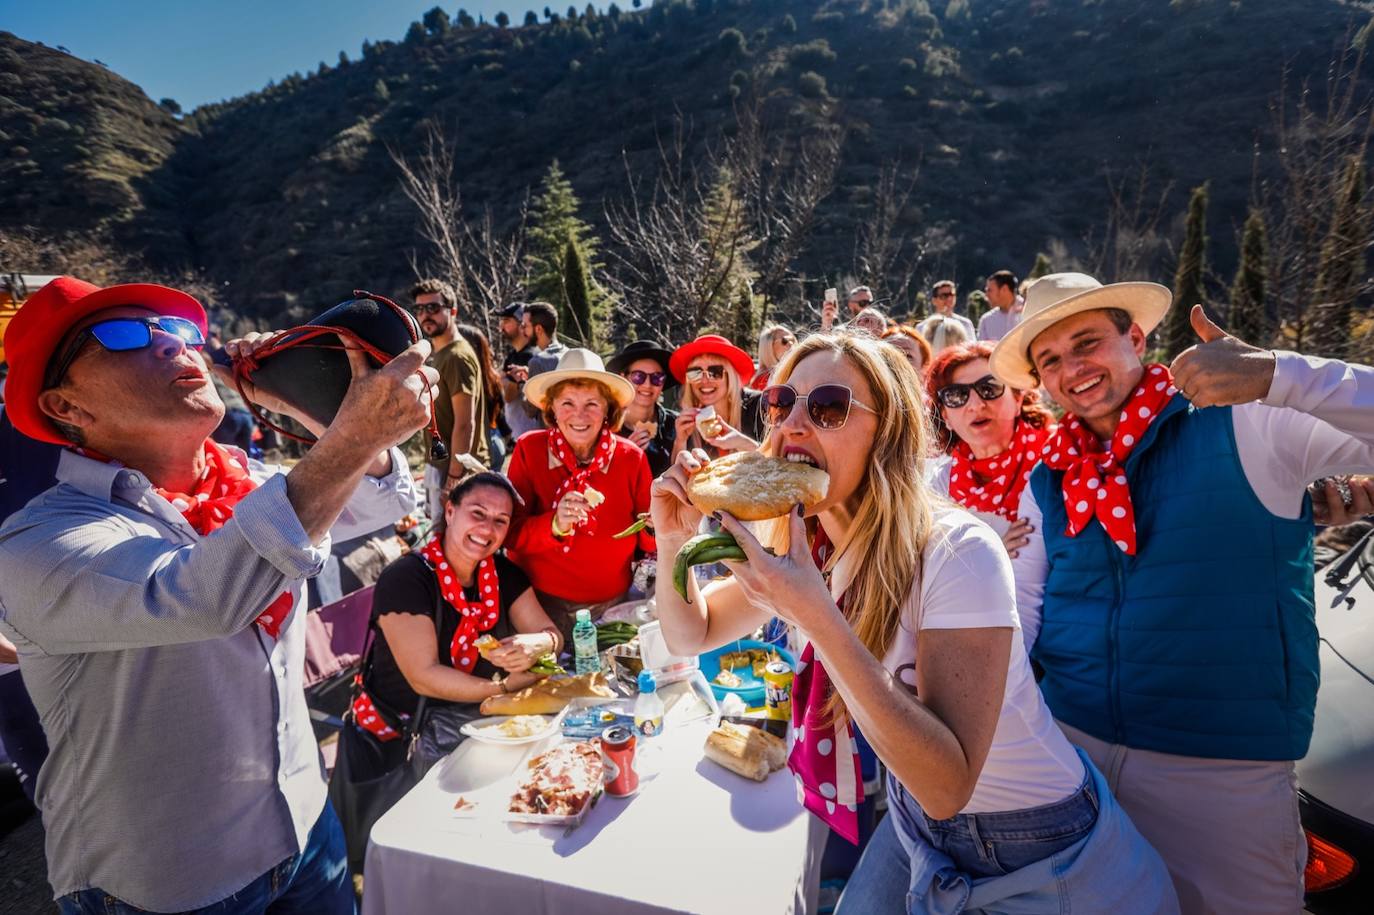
top-left (1040, 364), bottom-right (1179, 556)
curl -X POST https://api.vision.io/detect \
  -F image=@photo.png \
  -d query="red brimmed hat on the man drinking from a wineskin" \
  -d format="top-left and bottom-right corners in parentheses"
top-left (4, 276), bottom-right (206, 445)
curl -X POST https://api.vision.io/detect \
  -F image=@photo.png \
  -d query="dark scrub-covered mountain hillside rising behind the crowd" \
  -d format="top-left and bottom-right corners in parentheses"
top-left (0, 0), bottom-right (1370, 328)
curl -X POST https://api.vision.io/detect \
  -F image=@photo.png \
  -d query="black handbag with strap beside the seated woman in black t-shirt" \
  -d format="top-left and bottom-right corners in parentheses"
top-left (330, 555), bottom-right (444, 874)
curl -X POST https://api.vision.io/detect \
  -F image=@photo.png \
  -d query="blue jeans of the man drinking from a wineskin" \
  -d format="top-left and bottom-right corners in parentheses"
top-left (58, 801), bottom-right (357, 915)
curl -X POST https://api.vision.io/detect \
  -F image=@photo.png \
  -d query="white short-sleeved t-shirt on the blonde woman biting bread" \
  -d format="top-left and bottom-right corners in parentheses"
top-left (831, 507), bottom-right (1085, 813)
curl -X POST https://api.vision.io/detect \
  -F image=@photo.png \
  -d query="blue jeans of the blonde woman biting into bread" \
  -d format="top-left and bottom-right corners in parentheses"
top-left (835, 778), bottom-right (1098, 915)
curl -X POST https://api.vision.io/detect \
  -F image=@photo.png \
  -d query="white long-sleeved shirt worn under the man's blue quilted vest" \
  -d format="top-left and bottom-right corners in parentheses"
top-left (1011, 352), bottom-right (1374, 650)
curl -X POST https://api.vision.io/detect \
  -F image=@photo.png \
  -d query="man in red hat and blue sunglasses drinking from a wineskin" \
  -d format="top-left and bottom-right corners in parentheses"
top-left (0, 278), bottom-right (434, 912)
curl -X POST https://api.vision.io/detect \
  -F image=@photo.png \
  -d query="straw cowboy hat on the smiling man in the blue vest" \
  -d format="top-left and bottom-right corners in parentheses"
top-left (988, 273), bottom-right (1173, 390)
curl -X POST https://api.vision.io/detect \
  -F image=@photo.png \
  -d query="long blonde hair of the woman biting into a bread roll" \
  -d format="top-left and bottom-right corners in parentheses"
top-left (760, 331), bottom-right (934, 721)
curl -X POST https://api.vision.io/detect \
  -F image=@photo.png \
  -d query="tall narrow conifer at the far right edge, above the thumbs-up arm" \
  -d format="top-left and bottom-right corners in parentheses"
top-left (1311, 150), bottom-right (1370, 359)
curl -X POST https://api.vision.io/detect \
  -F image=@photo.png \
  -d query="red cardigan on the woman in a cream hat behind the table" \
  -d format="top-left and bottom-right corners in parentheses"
top-left (506, 429), bottom-right (655, 603)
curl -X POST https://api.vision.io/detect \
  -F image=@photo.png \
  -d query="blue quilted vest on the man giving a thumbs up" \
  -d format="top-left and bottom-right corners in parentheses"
top-left (1031, 396), bottom-right (1318, 760)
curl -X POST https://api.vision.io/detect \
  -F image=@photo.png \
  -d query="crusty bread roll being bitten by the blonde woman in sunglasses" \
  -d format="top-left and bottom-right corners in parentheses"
top-left (687, 451), bottom-right (830, 521)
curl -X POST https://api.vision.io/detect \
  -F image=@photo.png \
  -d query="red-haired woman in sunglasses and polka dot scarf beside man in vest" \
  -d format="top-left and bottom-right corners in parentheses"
top-left (926, 342), bottom-right (1054, 558)
